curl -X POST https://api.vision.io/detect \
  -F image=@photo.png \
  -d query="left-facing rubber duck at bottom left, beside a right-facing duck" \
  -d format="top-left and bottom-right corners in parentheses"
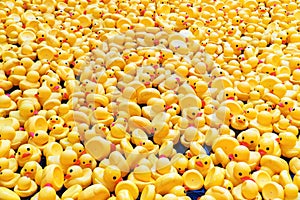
top-left (64, 166), bottom-right (92, 188)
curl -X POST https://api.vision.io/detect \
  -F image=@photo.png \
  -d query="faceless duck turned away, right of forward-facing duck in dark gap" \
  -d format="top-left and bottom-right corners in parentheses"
top-left (249, 111), bottom-right (273, 134)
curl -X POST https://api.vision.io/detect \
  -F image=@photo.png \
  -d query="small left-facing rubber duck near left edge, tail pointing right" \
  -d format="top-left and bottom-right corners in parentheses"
top-left (28, 130), bottom-right (55, 151)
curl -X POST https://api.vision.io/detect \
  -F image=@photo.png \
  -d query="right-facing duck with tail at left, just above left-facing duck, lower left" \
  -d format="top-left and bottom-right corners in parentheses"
top-left (46, 147), bottom-right (79, 172)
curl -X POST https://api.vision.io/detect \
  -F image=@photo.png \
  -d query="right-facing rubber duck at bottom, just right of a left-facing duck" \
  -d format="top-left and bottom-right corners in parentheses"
top-left (92, 165), bottom-right (123, 192)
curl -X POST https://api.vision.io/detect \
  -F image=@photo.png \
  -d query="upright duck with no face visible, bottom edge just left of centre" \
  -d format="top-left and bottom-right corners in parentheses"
top-left (128, 165), bottom-right (154, 192)
